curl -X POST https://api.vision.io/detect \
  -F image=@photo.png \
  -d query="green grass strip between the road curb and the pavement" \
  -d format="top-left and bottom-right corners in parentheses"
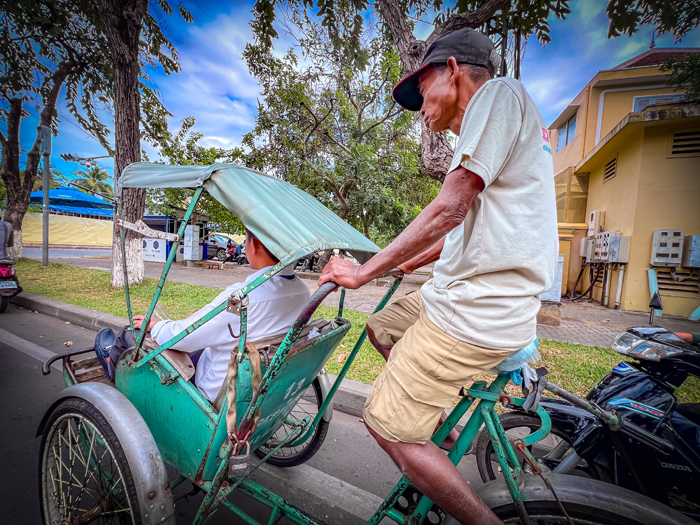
top-left (16, 259), bottom-right (622, 395)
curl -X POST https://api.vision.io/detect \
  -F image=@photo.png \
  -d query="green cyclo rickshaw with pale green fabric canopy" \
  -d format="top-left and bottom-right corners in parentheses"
top-left (38, 163), bottom-right (688, 525)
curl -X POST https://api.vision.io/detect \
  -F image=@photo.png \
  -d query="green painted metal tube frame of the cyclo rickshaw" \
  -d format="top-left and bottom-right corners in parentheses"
top-left (112, 182), bottom-right (551, 525)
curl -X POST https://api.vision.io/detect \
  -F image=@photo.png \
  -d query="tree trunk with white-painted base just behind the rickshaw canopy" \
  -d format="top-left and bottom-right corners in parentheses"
top-left (99, 0), bottom-right (148, 286)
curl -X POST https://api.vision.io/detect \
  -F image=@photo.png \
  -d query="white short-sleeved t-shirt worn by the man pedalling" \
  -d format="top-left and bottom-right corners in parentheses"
top-left (421, 78), bottom-right (558, 351)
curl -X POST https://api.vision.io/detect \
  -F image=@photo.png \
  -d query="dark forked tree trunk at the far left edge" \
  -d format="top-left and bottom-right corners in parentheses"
top-left (0, 61), bottom-right (76, 259)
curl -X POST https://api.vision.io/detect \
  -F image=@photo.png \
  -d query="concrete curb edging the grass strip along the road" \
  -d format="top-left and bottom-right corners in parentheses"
top-left (10, 292), bottom-right (372, 417)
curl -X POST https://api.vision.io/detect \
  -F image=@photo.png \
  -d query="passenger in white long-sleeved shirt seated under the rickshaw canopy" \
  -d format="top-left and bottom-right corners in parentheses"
top-left (95, 231), bottom-right (311, 403)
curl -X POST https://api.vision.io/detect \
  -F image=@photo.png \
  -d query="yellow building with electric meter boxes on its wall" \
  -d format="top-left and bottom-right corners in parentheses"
top-left (550, 49), bottom-right (700, 317)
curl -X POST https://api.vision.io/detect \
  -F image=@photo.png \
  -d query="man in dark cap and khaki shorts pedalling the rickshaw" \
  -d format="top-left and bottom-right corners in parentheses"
top-left (319, 29), bottom-right (558, 525)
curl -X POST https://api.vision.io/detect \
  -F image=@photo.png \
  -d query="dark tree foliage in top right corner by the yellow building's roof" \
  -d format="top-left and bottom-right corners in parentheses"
top-left (606, 0), bottom-right (700, 100)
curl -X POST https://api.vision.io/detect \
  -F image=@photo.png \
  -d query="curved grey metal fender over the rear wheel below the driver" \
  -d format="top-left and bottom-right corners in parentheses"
top-left (474, 474), bottom-right (697, 525)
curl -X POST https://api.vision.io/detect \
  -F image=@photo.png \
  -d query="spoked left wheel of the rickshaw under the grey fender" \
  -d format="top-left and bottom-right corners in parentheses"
top-left (39, 398), bottom-right (143, 525)
